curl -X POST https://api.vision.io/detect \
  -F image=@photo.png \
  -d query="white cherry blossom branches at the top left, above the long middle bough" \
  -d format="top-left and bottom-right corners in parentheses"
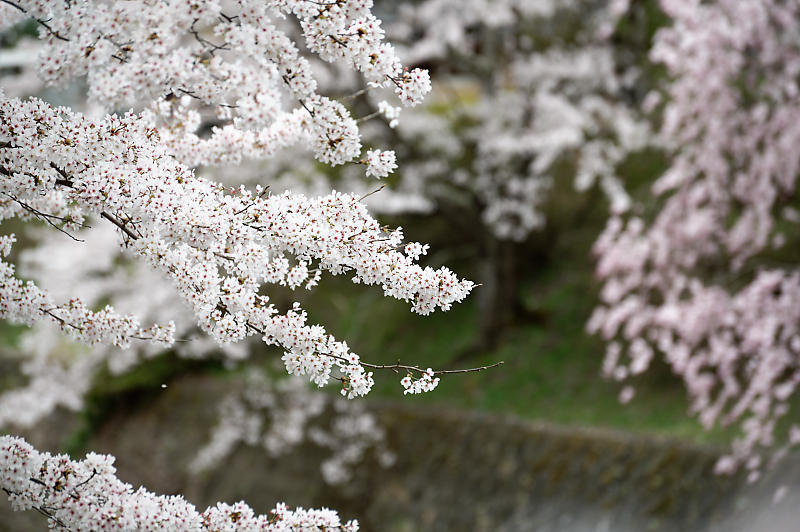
top-left (0, 0), bottom-right (430, 170)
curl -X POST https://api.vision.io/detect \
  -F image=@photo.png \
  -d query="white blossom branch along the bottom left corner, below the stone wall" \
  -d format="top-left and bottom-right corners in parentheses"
top-left (0, 436), bottom-right (358, 532)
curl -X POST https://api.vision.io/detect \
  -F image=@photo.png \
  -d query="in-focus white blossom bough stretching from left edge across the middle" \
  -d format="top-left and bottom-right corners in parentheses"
top-left (0, 95), bottom-right (472, 396)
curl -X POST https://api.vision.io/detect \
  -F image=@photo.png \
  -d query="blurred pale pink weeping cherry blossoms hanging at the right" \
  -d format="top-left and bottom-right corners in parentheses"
top-left (589, 0), bottom-right (800, 479)
